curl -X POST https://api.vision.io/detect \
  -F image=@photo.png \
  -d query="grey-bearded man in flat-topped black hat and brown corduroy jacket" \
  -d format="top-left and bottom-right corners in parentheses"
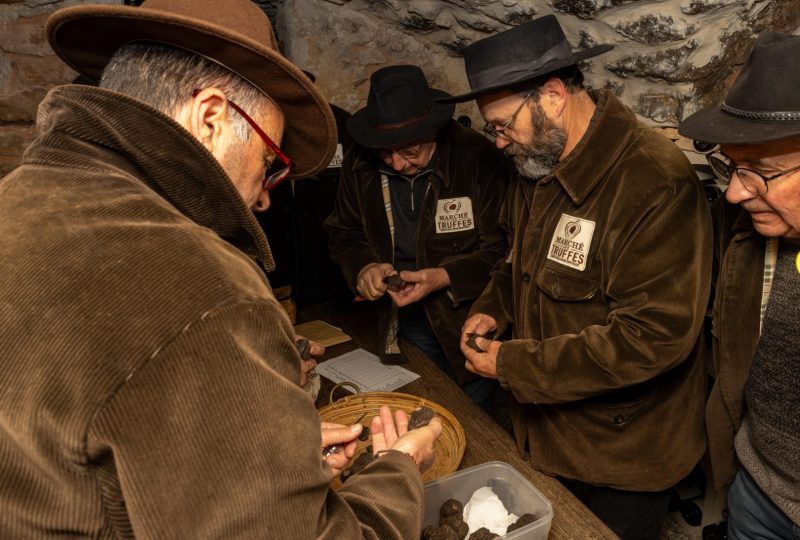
top-left (446, 16), bottom-right (711, 539)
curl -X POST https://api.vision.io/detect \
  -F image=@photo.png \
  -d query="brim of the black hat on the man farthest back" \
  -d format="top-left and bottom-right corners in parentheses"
top-left (347, 88), bottom-right (456, 148)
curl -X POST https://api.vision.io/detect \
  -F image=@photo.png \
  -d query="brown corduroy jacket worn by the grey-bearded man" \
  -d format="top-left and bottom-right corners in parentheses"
top-left (472, 92), bottom-right (712, 491)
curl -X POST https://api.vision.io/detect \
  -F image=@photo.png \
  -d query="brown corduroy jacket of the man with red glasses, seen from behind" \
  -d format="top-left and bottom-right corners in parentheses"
top-left (0, 86), bottom-right (422, 540)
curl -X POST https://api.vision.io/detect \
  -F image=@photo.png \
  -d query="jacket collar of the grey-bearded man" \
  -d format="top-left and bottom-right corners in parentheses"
top-left (554, 90), bottom-right (637, 204)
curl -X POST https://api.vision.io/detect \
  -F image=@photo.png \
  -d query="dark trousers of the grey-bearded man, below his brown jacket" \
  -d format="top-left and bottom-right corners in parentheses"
top-left (559, 478), bottom-right (672, 540)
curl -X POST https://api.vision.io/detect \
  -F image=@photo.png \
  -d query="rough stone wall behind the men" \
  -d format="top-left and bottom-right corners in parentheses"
top-left (0, 0), bottom-right (800, 175)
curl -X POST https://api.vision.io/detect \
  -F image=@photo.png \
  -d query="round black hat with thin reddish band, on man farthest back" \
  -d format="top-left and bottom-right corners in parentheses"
top-left (347, 65), bottom-right (456, 148)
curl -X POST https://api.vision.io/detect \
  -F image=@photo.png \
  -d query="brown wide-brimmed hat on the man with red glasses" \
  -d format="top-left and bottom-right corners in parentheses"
top-left (46, 0), bottom-right (336, 177)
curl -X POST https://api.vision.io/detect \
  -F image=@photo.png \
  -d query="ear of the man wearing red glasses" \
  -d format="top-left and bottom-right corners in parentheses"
top-left (176, 87), bottom-right (230, 154)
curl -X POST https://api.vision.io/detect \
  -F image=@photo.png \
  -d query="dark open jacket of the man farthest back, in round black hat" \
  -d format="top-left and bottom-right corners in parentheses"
top-left (325, 121), bottom-right (510, 384)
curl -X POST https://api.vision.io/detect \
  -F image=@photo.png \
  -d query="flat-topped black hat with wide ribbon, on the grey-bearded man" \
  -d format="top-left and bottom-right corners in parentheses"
top-left (442, 15), bottom-right (614, 103)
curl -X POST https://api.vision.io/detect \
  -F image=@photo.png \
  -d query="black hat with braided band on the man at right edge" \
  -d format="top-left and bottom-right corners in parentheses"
top-left (678, 32), bottom-right (800, 144)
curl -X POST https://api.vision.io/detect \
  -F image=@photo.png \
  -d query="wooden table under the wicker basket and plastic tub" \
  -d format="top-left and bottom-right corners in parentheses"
top-left (304, 302), bottom-right (617, 539)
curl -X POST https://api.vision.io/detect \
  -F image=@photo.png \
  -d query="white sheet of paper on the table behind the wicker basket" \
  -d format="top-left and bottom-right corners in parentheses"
top-left (315, 349), bottom-right (419, 392)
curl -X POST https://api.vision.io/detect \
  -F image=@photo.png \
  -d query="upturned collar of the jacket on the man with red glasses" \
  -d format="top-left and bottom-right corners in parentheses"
top-left (23, 85), bottom-right (275, 271)
